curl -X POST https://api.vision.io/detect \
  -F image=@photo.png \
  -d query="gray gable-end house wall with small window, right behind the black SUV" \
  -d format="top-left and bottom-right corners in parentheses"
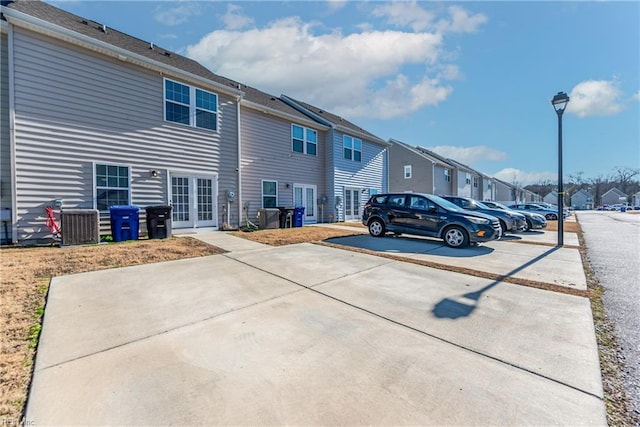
top-left (389, 139), bottom-right (455, 195)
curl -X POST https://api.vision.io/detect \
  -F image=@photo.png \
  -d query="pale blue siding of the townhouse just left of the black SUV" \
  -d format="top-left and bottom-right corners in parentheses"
top-left (327, 130), bottom-right (389, 221)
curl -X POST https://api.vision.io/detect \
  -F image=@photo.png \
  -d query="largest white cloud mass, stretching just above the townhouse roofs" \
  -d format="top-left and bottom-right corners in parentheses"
top-left (186, 2), bottom-right (484, 119)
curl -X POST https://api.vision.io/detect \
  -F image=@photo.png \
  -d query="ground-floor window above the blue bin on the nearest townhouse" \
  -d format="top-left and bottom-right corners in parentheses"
top-left (94, 164), bottom-right (131, 211)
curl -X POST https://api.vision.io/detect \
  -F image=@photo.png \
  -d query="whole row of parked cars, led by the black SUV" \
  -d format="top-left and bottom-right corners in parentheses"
top-left (362, 193), bottom-right (547, 248)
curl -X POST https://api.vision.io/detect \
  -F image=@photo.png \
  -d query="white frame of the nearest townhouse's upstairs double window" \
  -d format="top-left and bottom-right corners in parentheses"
top-left (162, 77), bottom-right (220, 132)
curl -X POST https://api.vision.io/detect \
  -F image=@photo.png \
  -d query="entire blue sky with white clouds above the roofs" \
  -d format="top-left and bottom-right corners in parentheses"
top-left (49, 0), bottom-right (640, 185)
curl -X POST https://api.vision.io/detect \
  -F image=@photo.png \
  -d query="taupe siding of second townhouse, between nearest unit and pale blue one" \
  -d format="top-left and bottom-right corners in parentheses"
top-left (240, 107), bottom-right (327, 222)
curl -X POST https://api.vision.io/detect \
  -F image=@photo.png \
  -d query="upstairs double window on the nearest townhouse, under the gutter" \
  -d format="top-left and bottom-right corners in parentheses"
top-left (164, 79), bottom-right (218, 130)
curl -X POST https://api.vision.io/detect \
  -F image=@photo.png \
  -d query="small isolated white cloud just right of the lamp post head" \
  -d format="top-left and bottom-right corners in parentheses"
top-left (567, 80), bottom-right (622, 117)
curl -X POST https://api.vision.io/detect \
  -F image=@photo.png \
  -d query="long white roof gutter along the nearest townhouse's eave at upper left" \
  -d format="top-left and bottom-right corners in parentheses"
top-left (2, 7), bottom-right (244, 97)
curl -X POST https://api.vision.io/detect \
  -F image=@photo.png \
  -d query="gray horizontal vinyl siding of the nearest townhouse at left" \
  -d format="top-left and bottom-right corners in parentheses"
top-left (14, 28), bottom-right (238, 240)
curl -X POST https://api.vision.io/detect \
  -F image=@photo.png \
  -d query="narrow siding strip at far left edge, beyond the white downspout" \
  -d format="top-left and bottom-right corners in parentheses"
top-left (0, 33), bottom-right (12, 242)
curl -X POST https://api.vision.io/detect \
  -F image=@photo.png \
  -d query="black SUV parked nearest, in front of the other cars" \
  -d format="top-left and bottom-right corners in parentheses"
top-left (362, 193), bottom-right (502, 248)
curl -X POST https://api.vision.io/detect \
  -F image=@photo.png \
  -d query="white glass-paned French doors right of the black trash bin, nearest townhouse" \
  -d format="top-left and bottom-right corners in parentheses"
top-left (171, 174), bottom-right (218, 228)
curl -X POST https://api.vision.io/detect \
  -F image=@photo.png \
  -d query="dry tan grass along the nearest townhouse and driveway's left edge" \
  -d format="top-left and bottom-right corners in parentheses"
top-left (0, 237), bottom-right (224, 425)
